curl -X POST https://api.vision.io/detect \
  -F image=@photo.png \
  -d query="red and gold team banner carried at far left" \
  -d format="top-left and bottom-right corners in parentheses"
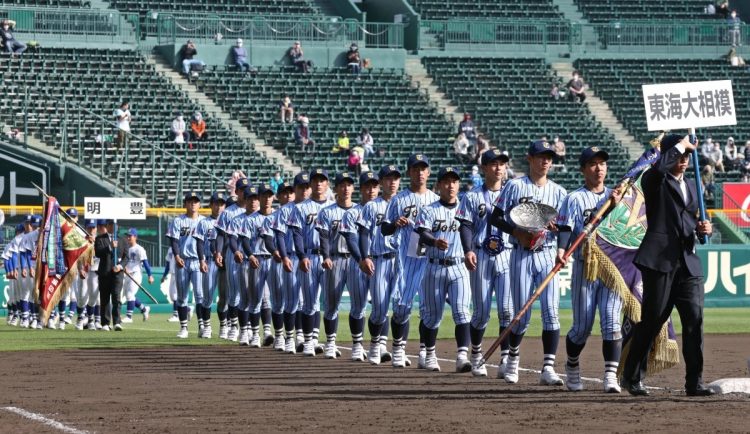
top-left (34, 196), bottom-right (93, 323)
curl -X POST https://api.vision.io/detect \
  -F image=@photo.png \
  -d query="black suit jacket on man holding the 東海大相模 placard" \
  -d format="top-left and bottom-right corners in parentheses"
top-left (633, 147), bottom-right (703, 276)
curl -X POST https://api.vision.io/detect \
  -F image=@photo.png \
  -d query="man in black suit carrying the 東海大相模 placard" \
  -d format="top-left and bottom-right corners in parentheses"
top-left (622, 134), bottom-right (712, 396)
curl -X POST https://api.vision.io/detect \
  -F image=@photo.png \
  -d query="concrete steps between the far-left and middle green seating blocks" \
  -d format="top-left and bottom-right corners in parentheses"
top-left (146, 54), bottom-right (302, 174)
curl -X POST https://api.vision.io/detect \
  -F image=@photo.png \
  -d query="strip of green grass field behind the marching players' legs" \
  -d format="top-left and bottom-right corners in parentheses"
top-left (0, 308), bottom-right (750, 351)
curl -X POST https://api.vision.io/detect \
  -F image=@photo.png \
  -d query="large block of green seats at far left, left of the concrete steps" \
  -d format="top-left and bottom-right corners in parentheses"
top-left (0, 48), bottom-right (277, 205)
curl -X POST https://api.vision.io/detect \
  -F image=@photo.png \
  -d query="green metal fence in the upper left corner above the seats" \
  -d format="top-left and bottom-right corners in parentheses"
top-left (0, 5), bottom-right (140, 44)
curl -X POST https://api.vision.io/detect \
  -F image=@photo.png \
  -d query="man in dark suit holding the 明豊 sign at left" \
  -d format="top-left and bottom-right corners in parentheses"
top-left (94, 220), bottom-right (123, 331)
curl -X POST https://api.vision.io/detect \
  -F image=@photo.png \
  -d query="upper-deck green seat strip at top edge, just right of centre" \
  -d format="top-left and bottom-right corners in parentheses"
top-left (408, 0), bottom-right (563, 20)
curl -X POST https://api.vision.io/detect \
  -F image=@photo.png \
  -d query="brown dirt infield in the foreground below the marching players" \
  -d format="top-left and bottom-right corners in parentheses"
top-left (0, 335), bottom-right (750, 433)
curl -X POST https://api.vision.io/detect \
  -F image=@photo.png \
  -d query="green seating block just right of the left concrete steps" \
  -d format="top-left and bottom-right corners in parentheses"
top-left (198, 67), bottom-right (455, 174)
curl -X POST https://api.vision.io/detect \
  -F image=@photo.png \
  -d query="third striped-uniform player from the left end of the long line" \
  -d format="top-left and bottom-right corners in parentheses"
top-left (214, 178), bottom-right (250, 342)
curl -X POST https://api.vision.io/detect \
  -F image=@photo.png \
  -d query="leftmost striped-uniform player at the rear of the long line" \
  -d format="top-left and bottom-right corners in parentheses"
top-left (167, 191), bottom-right (203, 339)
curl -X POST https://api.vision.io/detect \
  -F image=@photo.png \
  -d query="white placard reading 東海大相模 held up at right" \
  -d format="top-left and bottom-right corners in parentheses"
top-left (643, 80), bottom-right (737, 131)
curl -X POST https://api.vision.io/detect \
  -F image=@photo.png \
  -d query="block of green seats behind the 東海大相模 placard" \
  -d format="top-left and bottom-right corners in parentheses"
top-left (575, 59), bottom-right (750, 182)
